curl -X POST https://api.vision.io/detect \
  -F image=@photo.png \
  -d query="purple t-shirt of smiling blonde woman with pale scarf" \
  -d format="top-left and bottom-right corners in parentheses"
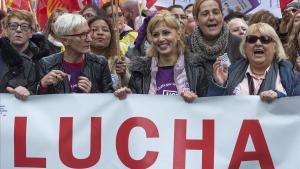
top-left (156, 66), bottom-right (178, 95)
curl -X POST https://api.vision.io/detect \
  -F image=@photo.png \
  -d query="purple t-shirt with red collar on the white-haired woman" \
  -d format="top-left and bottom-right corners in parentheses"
top-left (63, 60), bottom-right (84, 93)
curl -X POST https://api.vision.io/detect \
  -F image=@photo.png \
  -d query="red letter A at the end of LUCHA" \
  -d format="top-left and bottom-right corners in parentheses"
top-left (229, 120), bottom-right (275, 169)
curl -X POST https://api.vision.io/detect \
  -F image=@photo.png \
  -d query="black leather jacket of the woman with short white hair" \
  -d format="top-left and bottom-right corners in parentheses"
top-left (37, 53), bottom-right (113, 94)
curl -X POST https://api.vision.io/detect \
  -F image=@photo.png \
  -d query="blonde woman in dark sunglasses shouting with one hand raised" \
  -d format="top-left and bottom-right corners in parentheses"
top-left (208, 23), bottom-right (300, 102)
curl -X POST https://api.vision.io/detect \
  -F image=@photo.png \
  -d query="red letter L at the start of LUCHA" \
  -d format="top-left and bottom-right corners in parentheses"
top-left (14, 117), bottom-right (46, 168)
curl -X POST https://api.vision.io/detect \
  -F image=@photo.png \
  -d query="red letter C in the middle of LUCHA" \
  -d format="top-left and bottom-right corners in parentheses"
top-left (116, 117), bottom-right (159, 168)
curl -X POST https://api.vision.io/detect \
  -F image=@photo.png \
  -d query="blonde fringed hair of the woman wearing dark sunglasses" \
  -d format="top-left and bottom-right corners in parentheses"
top-left (240, 22), bottom-right (287, 61)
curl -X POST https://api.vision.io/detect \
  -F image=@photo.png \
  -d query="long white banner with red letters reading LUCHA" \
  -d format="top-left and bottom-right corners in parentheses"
top-left (0, 94), bottom-right (300, 169)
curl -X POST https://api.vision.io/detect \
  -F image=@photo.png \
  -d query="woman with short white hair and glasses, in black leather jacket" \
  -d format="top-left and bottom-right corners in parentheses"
top-left (38, 13), bottom-right (113, 94)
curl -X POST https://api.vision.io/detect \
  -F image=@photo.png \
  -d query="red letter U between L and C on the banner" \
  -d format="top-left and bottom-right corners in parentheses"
top-left (59, 117), bottom-right (101, 168)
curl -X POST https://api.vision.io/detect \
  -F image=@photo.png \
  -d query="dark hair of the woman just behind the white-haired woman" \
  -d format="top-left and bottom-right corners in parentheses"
top-left (88, 15), bottom-right (117, 58)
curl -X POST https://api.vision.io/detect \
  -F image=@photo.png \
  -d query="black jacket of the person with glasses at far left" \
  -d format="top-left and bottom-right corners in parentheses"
top-left (0, 38), bottom-right (36, 93)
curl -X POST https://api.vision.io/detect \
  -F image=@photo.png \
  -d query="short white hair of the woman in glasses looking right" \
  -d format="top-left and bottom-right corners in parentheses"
top-left (53, 13), bottom-right (87, 37)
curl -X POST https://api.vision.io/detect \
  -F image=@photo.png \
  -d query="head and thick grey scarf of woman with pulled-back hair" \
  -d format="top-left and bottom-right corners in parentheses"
top-left (189, 0), bottom-right (241, 77)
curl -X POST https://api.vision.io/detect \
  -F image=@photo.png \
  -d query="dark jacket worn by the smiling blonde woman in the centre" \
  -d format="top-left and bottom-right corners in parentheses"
top-left (128, 53), bottom-right (208, 97)
